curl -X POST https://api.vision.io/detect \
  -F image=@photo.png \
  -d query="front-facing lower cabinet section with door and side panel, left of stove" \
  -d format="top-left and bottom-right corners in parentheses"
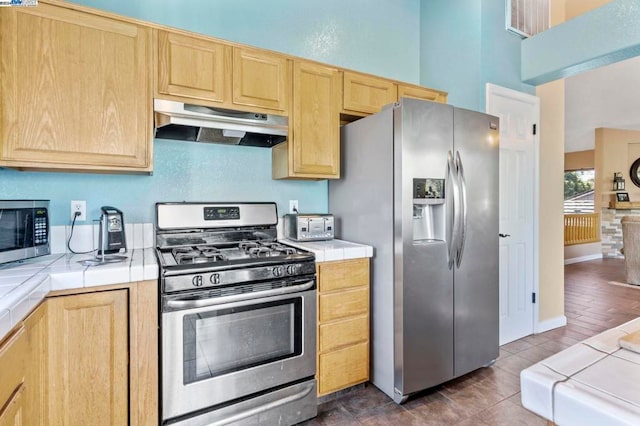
top-left (47, 281), bottom-right (158, 426)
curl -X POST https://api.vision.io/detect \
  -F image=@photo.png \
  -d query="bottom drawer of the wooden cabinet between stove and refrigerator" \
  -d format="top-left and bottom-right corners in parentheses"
top-left (318, 342), bottom-right (369, 395)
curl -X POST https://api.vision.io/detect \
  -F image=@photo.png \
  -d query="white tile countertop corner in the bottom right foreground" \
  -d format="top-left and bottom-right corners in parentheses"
top-left (520, 318), bottom-right (640, 426)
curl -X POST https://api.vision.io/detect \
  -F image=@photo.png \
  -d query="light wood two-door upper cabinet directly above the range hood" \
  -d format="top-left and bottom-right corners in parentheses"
top-left (156, 30), bottom-right (291, 115)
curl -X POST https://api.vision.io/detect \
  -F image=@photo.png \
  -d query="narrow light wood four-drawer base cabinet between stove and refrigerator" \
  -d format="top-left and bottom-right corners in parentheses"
top-left (317, 258), bottom-right (369, 396)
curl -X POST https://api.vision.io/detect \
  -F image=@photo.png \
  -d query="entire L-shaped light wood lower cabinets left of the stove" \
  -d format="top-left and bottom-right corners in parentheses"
top-left (0, 281), bottom-right (158, 426)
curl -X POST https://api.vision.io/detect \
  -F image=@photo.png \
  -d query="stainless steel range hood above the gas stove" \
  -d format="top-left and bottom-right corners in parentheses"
top-left (153, 99), bottom-right (289, 148)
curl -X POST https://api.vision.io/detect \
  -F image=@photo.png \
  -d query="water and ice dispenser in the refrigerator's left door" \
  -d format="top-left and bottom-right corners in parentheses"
top-left (413, 179), bottom-right (446, 242)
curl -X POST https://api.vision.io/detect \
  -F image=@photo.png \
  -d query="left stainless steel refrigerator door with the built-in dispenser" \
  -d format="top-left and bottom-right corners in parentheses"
top-left (394, 98), bottom-right (453, 402)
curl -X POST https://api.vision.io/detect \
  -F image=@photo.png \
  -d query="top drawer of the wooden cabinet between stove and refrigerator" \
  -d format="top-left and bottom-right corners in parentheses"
top-left (318, 258), bottom-right (369, 291)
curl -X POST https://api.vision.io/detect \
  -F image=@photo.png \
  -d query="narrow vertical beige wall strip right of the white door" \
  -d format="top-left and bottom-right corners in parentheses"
top-left (536, 80), bottom-right (564, 321)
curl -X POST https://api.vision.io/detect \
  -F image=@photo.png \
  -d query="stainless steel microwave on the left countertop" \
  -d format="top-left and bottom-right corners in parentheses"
top-left (0, 200), bottom-right (51, 263)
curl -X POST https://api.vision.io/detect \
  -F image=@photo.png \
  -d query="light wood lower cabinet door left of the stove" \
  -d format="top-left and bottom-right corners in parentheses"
top-left (47, 290), bottom-right (129, 425)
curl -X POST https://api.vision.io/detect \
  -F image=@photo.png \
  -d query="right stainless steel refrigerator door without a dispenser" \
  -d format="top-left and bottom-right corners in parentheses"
top-left (454, 108), bottom-right (499, 376)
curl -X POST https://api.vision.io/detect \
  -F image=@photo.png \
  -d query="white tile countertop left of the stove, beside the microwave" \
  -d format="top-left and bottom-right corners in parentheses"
top-left (0, 248), bottom-right (158, 339)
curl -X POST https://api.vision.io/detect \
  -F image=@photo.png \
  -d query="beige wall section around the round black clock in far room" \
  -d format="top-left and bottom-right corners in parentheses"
top-left (595, 128), bottom-right (640, 211)
